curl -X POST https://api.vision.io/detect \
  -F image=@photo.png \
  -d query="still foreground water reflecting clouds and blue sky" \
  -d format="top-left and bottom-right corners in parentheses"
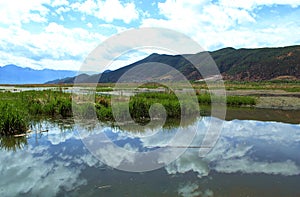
top-left (0, 117), bottom-right (300, 197)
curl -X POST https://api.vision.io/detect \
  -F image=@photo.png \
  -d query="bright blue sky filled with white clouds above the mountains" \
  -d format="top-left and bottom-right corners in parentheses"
top-left (0, 0), bottom-right (300, 70)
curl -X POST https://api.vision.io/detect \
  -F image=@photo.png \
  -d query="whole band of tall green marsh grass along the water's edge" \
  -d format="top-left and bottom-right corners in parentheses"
top-left (0, 84), bottom-right (256, 135)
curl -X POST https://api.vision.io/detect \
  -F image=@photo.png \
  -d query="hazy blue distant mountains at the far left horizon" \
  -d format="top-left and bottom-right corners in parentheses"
top-left (0, 64), bottom-right (77, 84)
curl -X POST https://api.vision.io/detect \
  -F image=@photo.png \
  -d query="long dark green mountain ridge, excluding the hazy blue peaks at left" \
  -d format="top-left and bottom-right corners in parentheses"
top-left (45, 46), bottom-right (300, 83)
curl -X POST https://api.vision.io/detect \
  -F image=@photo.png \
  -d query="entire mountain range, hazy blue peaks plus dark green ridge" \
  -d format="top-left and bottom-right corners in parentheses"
top-left (0, 45), bottom-right (300, 84)
